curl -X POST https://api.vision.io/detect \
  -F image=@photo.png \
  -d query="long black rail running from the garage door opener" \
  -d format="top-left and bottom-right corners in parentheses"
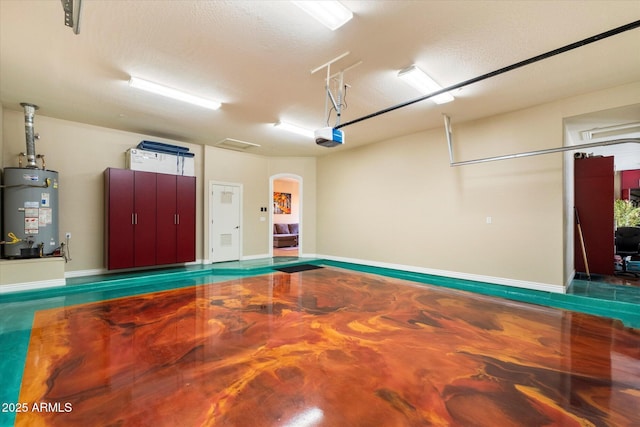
top-left (336, 21), bottom-right (640, 129)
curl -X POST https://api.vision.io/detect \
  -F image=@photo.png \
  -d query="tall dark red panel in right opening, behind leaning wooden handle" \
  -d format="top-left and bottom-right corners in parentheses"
top-left (574, 157), bottom-right (615, 275)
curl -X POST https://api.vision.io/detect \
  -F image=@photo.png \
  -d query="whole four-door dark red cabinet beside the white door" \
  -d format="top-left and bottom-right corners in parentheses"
top-left (105, 168), bottom-right (196, 270)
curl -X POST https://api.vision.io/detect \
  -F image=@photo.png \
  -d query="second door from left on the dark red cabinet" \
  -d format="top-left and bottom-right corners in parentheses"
top-left (133, 171), bottom-right (156, 267)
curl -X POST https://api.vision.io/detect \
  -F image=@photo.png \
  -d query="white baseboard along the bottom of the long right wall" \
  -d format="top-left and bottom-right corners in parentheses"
top-left (317, 255), bottom-right (566, 294)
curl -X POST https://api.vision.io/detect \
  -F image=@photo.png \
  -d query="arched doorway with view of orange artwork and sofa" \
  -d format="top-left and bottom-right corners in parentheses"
top-left (269, 173), bottom-right (304, 257)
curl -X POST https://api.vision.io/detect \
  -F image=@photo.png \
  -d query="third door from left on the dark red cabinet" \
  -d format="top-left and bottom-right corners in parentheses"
top-left (156, 174), bottom-right (178, 264)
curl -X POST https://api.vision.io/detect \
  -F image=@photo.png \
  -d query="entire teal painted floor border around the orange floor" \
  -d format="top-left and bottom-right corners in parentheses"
top-left (0, 258), bottom-right (640, 425)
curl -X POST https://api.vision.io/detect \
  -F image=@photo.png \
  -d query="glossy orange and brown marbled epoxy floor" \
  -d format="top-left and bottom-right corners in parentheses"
top-left (10, 267), bottom-right (640, 427)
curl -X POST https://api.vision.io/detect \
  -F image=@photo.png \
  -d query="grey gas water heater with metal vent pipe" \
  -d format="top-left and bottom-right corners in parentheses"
top-left (2, 103), bottom-right (60, 258)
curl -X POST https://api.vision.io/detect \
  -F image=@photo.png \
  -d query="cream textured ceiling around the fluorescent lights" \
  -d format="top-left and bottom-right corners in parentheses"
top-left (0, 0), bottom-right (640, 156)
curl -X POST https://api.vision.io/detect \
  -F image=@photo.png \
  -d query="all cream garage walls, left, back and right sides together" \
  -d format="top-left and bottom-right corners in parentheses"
top-left (0, 82), bottom-right (640, 287)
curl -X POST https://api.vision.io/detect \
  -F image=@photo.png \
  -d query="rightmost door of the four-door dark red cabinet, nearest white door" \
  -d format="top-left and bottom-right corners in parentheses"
top-left (176, 175), bottom-right (196, 262)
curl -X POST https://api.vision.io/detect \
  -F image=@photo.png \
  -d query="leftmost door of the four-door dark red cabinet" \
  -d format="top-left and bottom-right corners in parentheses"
top-left (105, 168), bottom-right (134, 270)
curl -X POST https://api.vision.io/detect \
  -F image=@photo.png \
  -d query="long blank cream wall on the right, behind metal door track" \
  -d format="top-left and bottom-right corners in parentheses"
top-left (317, 84), bottom-right (640, 291)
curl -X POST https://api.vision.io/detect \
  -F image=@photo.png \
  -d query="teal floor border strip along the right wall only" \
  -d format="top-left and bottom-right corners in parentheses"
top-left (319, 260), bottom-right (640, 328)
